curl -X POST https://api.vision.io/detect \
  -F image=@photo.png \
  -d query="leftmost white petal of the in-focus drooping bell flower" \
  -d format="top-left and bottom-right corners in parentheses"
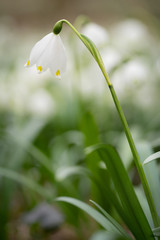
top-left (29, 33), bottom-right (53, 66)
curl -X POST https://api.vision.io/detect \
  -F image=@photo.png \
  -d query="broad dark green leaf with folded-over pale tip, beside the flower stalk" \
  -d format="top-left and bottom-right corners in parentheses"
top-left (87, 144), bottom-right (154, 240)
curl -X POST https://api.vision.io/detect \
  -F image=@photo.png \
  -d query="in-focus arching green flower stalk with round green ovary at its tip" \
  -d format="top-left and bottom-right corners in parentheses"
top-left (53, 19), bottom-right (160, 227)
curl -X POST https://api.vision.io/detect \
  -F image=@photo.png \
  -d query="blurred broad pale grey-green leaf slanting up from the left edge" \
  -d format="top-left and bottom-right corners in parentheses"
top-left (0, 118), bottom-right (45, 170)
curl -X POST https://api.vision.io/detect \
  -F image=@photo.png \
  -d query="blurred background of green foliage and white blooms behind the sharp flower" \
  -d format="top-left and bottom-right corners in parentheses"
top-left (0, 0), bottom-right (160, 240)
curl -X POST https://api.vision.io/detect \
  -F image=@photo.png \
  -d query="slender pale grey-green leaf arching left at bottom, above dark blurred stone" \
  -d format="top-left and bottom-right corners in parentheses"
top-left (56, 197), bottom-right (129, 235)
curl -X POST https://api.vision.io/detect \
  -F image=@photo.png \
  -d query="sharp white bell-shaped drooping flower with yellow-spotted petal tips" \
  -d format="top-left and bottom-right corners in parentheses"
top-left (25, 33), bottom-right (66, 77)
